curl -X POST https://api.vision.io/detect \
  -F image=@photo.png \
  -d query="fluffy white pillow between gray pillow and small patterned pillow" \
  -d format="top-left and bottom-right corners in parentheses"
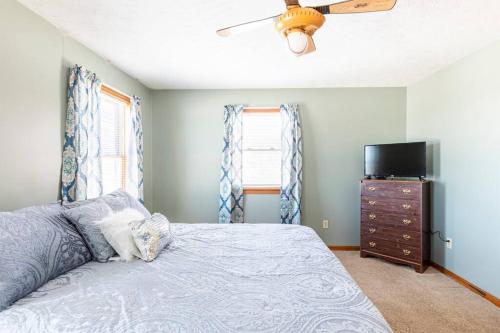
top-left (96, 208), bottom-right (145, 261)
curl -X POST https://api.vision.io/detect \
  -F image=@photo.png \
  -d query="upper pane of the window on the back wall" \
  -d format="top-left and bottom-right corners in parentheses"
top-left (243, 112), bottom-right (281, 150)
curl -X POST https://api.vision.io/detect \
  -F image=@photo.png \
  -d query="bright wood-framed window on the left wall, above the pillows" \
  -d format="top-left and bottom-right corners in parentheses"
top-left (101, 85), bottom-right (130, 194)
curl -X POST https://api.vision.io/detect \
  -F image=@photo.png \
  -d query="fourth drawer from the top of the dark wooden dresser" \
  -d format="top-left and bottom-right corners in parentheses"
top-left (361, 223), bottom-right (421, 247)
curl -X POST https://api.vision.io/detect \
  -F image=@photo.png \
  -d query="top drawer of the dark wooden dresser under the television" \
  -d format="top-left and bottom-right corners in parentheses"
top-left (361, 180), bottom-right (421, 200)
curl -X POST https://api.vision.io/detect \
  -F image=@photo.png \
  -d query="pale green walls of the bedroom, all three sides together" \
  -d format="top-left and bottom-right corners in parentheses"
top-left (4, 0), bottom-right (500, 297)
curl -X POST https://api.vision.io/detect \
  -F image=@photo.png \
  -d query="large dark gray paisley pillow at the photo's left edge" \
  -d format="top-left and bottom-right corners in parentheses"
top-left (0, 204), bottom-right (92, 311)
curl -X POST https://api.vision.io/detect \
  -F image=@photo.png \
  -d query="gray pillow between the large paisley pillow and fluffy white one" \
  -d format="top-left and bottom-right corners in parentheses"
top-left (64, 200), bottom-right (115, 262)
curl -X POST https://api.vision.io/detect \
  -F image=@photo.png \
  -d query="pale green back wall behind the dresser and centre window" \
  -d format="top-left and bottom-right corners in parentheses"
top-left (153, 88), bottom-right (406, 245)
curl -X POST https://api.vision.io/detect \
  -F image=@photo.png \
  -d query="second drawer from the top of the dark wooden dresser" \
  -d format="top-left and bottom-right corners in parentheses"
top-left (361, 196), bottom-right (421, 216)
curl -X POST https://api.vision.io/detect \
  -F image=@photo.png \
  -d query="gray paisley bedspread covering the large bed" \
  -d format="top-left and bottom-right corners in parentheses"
top-left (0, 224), bottom-right (391, 333)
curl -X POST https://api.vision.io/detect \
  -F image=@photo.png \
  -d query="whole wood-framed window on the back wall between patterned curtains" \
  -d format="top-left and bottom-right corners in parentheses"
top-left (242, 108), bottom-right (281, 194)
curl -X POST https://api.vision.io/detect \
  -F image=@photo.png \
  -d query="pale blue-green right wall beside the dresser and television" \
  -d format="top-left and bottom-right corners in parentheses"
top-left (407, 43), bottom-right (500, 297)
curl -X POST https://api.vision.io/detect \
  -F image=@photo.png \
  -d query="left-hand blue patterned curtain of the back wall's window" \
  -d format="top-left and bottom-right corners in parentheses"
top-left (219, 105), bottom-right (243, 223)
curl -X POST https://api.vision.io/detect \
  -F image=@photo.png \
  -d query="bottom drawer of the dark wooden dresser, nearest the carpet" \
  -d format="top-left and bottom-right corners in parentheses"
top-left (361, 235), bottom-right (421, 262)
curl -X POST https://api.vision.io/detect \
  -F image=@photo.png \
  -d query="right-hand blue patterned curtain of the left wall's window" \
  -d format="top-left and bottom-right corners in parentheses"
top-left (127, 96), bottom-right (144, 203)
